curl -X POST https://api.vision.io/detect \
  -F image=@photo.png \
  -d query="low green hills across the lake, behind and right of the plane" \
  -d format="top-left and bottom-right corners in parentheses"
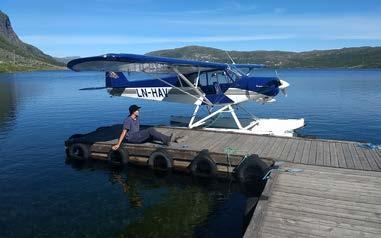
top-left (147, 46), bottom-right (381, 68)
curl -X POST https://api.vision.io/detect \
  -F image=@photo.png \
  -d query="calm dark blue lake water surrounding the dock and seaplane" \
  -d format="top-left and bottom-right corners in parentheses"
top-left (0, 70), bottom-right (381, 237)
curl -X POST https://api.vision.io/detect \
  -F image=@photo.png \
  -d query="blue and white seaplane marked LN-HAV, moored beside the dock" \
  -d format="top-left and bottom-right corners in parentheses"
top-left (67, 54), bottom-right (305, 137)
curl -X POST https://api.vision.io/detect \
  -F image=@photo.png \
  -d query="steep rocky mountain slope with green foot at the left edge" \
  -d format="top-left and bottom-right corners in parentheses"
top-left (0, 11), bottom-right (65, 72)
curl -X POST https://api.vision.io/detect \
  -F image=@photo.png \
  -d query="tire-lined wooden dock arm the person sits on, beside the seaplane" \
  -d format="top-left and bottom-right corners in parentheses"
top-left (66, 126), bottom-right (381, 171)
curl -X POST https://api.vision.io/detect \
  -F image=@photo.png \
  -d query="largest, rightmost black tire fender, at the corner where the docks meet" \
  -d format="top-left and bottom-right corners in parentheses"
top-left (235, 154), bottom-right (269, 183)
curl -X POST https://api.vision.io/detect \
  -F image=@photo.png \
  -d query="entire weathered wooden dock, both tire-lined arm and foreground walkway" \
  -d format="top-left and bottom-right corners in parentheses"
top-left (65, 125), bottom-right (381, 237)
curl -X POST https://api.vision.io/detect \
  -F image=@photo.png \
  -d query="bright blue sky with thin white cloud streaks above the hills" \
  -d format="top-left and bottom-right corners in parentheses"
top-left (0, 0), bottom-right (381, 57)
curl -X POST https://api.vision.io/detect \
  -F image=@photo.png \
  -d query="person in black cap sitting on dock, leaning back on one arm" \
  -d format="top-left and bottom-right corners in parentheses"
top-left (112, 105), bottom-right (178, 150)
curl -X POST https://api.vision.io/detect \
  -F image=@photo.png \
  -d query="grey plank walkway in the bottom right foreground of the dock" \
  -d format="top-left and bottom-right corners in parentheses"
top-left (244, 163), bottom-right (381, 238)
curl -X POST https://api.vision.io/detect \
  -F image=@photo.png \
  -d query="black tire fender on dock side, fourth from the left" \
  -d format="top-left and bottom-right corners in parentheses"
top-left (189, 149), bottom-right (217, 178)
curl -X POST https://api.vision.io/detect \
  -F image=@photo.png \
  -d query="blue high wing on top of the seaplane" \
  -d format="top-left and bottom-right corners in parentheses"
top-left (67, 54), bottom-right (264, 74)
